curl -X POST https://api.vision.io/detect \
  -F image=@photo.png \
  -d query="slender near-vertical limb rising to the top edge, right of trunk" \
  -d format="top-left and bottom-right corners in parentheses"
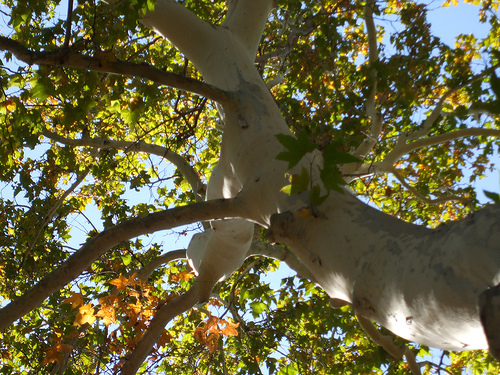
top-left (353, 0), bottom-right (383, 159)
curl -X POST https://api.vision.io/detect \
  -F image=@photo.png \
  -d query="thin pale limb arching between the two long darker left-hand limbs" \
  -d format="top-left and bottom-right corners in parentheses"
top-left (42, 130), bottom-right (206, 201)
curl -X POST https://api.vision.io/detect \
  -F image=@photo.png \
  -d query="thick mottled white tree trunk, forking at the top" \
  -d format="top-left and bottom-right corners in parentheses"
top-left (143, 0), bottom-right (500, 358)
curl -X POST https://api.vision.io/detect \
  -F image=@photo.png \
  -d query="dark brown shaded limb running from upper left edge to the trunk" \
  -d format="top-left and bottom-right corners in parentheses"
top-left (0, 36), bottom-right (232, 106)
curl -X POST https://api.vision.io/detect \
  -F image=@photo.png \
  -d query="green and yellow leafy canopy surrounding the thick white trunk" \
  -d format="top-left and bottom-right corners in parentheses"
top-left (0, 0), bottom-right (500, 374)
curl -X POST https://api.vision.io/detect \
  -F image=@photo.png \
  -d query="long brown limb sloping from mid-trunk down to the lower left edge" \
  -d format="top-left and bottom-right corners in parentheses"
top-left (0, 198), bottom-right (241, 331)
